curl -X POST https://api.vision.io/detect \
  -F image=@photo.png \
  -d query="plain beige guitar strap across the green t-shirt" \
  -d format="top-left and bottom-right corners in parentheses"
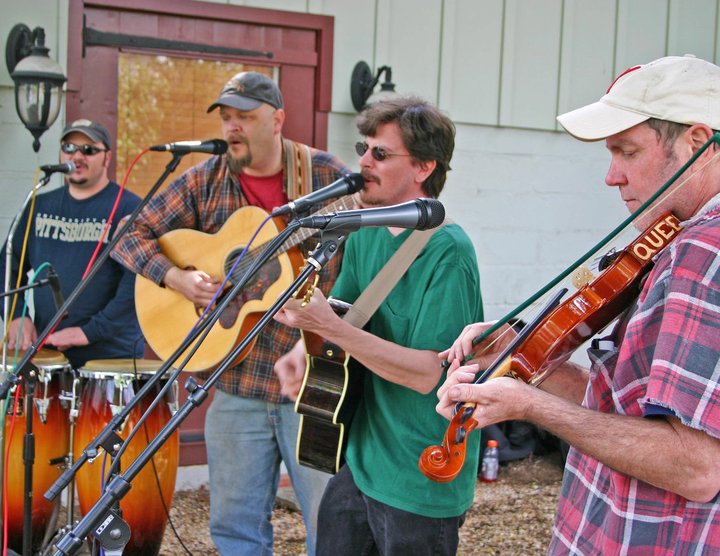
top-left (343, 220), bottom-right (449, 328)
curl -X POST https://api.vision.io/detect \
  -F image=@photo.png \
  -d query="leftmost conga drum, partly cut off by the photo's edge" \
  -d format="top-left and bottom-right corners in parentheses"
top-left (3, 349), bottom-right (72, 553)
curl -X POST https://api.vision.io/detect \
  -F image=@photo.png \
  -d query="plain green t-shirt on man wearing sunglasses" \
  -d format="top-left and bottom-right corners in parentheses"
top-left (332, 224), bottom-right (483, 518)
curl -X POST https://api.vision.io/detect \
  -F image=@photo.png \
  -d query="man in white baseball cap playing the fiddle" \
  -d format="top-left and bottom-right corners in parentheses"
top-left (438, 56), bottom-right (720, 555)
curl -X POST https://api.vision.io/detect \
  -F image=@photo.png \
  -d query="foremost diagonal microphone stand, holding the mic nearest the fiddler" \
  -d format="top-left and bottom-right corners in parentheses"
top-left (55, 230), bottom-right (346, 556)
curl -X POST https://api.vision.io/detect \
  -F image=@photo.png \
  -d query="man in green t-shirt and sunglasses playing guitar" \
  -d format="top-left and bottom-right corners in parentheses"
top-left (275, 98), bottom-right (482, 555)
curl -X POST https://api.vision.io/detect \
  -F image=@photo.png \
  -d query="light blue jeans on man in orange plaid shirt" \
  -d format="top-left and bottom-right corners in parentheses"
top-left (205, 390), bottom-right (330, 556)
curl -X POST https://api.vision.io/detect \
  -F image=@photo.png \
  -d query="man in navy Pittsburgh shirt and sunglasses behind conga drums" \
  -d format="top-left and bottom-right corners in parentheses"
top-left (0, 119), bottom-right (143, 374)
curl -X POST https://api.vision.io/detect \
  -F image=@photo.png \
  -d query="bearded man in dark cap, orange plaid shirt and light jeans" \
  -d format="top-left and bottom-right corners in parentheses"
top-left (113, 72), bottom-right (349, 555)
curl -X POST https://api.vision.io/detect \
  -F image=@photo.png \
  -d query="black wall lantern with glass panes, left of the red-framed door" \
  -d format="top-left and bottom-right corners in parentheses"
top-left (5, 23), bottom-right (66, 152)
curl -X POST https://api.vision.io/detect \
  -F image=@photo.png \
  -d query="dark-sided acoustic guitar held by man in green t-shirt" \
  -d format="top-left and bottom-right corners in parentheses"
top-left (295, 298), bottom-right (364, 474)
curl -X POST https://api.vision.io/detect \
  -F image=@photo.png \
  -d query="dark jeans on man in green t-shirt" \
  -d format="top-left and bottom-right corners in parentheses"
top-left (317, 465), bottom-right (465, 556)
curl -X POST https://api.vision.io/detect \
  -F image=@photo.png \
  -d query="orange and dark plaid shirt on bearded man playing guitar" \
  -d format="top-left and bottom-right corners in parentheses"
top-left (112, 141), bottom-right (350, 403)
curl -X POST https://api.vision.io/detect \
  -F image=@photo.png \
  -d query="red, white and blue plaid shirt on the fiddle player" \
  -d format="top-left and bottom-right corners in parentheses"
top-left (549, 199), bottom-right (720, 556)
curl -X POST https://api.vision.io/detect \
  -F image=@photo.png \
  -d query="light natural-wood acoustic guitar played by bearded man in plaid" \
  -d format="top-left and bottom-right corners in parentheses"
top-left (135, 196), bottom-right (354, 372)
